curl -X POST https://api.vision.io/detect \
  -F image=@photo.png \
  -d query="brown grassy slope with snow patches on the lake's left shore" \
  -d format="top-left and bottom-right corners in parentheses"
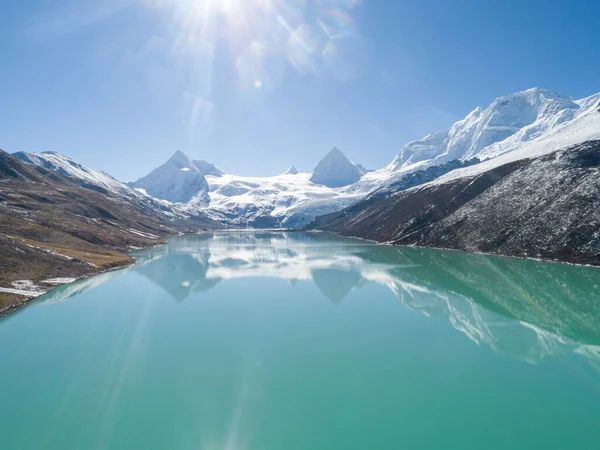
top-left (0, 150), bottom-right (219, 313)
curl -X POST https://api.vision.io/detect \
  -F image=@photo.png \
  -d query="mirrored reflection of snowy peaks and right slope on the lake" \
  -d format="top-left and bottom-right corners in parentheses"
top-left (39, 232), bottom-right (600, 363)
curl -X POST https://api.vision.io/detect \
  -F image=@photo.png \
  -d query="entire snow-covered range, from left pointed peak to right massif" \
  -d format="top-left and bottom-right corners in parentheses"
top-left (123, 88), bottom-right (600, 228)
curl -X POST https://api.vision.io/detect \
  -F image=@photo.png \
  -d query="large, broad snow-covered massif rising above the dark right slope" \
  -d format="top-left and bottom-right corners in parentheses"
top-left (388, 88), bottom-right (600, 171)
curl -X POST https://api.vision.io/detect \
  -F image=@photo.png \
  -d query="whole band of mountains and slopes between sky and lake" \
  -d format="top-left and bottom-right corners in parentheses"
top-left (0, 88), bottom-right (600, 308)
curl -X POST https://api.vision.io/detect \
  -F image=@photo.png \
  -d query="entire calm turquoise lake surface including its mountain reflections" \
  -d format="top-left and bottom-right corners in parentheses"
top-left (0, 232), bottom-right (600, 450)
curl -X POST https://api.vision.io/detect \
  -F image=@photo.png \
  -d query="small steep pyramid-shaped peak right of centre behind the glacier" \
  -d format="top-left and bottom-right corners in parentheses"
top-left (310, 147), bottom-right (366, 188)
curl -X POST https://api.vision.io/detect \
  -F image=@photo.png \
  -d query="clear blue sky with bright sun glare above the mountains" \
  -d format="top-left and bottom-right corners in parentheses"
top-left (0, 0), bottom-right (600, 181)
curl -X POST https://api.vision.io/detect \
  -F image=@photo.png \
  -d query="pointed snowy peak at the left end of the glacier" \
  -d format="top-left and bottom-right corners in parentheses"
top-left (131, 151), bottom-right (210, 203)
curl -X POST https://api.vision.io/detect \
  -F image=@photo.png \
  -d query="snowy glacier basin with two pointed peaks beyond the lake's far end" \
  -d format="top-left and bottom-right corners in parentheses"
top-left (131, 148), bottom-right (368, 228)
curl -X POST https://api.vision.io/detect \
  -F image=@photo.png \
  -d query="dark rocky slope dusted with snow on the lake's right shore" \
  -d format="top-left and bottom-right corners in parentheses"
top-left (310, 141), bottom-right (600, 265)
